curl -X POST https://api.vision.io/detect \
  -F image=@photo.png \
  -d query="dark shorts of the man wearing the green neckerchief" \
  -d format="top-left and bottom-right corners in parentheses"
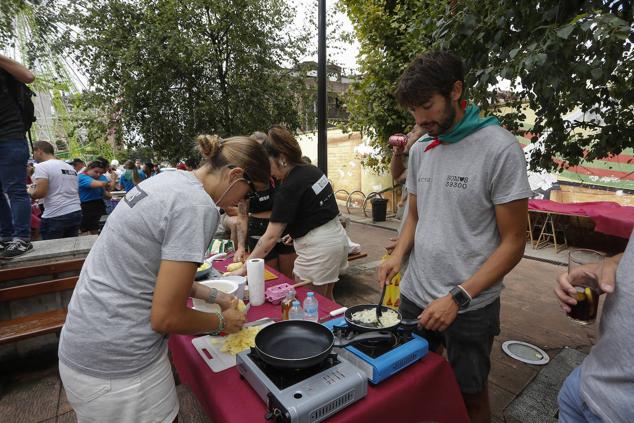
top-left (399, 295), bottom-right (500, 394)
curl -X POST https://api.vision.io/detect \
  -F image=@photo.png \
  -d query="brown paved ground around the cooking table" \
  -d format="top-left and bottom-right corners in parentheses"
top-left (0, 222), bottom-right (597, 422)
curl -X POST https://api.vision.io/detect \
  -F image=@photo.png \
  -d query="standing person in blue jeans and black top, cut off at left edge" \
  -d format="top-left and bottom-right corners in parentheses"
top-left (0, 54), bottom-right (35, 259)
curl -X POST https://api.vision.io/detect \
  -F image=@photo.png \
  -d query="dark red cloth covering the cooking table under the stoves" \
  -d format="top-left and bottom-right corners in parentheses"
top-left (169, 263), bottom-right (468, 423)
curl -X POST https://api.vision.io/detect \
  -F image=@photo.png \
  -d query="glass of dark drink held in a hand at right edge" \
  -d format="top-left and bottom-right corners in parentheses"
top-left (568, 249), bottom-right (605, 325)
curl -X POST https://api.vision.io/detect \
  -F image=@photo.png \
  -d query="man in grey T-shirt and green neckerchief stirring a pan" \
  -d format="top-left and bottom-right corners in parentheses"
top-left (378, 51), bottom-right (532, 423)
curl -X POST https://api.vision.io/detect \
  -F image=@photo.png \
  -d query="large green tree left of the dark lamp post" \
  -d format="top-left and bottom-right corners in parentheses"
top-left (59, 0), bottom-right (305, 160)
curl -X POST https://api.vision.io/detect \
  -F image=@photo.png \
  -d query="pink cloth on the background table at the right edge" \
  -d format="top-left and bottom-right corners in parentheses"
top-left (528, 200), bottom-right (634, 239)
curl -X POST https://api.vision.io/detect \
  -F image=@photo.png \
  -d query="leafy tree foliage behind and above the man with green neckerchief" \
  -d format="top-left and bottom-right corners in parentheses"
top-left (342, 0), bottom-right (634, 169)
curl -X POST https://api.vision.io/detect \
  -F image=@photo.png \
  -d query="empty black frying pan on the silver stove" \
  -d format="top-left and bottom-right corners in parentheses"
top-left (255, 320), bottom-right (393, 369)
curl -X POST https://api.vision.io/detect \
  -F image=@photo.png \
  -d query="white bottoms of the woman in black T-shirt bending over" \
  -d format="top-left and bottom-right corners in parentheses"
top-left (293, 217), bottom-right (348, 285)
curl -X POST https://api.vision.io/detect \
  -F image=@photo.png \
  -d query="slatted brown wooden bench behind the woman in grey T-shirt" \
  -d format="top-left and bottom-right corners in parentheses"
top-left (0, 258), bottom-right (84, 345)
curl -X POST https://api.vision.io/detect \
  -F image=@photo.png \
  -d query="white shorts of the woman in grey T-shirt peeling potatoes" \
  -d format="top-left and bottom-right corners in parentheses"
top-left (59, 349), bottom-right (178, 423)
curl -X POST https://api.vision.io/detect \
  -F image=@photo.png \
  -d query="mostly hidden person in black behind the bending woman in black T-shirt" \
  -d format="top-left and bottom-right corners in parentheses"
top-left (233, 132), bottom-right (296, 279)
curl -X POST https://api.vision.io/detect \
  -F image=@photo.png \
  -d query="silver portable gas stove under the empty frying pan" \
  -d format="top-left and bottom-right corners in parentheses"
top-left (236, 350), bottom-right (368, 423)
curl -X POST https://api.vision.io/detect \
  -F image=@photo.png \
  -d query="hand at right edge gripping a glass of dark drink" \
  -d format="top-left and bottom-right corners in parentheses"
top-left (555, 259), bottom-right (618, 313)
